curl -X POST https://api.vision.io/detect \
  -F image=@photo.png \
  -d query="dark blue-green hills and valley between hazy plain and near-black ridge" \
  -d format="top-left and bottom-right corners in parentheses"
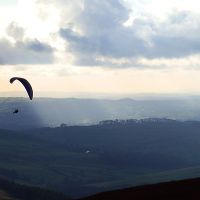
top-left (0, 122), bottom-right (200, 196)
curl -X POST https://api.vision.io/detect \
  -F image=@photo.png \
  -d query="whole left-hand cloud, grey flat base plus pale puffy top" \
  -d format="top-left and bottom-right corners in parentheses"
top-left (0, 21), bottom-right (55, 65)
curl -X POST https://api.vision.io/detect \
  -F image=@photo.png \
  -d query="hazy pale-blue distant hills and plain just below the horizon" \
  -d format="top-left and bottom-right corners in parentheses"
top-left (0, 97), bottom-right (200, 130)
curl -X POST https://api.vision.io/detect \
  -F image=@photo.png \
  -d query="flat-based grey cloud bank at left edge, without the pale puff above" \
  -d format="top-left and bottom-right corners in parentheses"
top-left (0, 39), bottom-right (53, 65)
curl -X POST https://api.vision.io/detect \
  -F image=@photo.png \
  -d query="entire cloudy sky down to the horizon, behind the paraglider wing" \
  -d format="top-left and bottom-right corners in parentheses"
top-left (0, 0), bottom-right (200, 97)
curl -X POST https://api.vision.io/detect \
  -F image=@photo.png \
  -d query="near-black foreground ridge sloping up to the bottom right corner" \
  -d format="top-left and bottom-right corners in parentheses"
top-left (81, 178), bottom-right (200, 200)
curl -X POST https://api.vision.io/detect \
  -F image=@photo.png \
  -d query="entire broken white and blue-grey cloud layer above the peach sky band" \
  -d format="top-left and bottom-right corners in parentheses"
top-left (0, 0), bottom-right (200, 68)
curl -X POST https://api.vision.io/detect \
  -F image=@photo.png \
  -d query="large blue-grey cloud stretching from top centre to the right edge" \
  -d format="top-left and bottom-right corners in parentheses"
top-left (57, 0), bottom-right (200, 65)
